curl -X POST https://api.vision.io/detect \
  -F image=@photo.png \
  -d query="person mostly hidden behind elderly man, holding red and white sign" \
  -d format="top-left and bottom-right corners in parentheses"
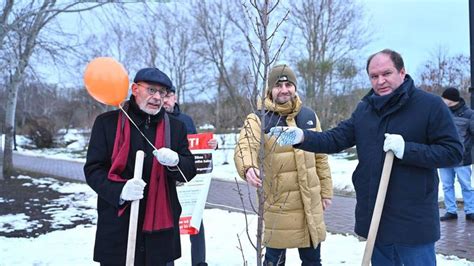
top-left (163, 87), bottom-right (217, 266)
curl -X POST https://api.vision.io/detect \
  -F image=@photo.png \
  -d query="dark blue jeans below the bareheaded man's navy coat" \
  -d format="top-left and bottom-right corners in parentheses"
top-left (372, 242), bottom-right (436, 266)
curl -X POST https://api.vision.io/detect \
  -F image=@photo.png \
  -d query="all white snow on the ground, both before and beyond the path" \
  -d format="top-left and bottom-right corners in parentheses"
top-left (0, 132), bottom-right (474, 266)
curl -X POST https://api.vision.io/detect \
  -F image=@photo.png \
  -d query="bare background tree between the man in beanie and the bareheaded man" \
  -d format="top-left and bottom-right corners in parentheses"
top-left (290, 0), bottom-right (370, 128)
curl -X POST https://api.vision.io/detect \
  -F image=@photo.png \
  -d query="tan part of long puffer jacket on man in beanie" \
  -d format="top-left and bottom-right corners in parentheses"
top-left (234, 96), bottom-right (333, 248)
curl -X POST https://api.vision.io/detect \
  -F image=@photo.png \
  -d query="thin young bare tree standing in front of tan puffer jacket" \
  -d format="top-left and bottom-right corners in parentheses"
top-left (232, 0), bottom-right (288, 265)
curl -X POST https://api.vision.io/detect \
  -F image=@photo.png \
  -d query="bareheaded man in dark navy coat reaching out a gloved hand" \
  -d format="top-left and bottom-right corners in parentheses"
top-left (272, 49), bottom-right (463, 265)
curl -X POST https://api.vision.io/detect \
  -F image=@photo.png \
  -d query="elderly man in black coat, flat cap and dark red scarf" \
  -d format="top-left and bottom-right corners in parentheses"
top-left (84, 68), bottom-right (196, 265)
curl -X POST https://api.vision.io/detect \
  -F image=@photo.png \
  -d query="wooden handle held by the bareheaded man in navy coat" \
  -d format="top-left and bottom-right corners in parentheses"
top-left (362, 151), bottom-right (393, 266)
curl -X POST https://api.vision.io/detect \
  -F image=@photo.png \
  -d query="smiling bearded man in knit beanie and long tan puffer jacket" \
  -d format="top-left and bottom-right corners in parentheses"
top-left (234, 65), bottom-right (333, 265)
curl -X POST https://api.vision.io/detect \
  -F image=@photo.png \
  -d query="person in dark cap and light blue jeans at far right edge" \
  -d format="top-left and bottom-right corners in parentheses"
top-left (439, 87), bottom-right (474, 222)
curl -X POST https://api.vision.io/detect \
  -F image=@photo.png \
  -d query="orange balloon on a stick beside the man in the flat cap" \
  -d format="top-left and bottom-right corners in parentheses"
top-left (84, 57), bottom-right (129, 106)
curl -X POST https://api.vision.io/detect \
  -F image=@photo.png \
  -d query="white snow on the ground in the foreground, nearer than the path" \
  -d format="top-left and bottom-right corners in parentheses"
top-left (0, 176), bottom-right (474, 266)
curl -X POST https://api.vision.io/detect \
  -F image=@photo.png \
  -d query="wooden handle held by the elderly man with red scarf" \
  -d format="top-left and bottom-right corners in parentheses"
top-left (126, 150), bottom-right (145, 266)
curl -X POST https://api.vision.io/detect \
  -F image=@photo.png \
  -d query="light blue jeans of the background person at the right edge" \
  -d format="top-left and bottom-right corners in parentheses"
top-left (439, 165), bottom-right (474, 214)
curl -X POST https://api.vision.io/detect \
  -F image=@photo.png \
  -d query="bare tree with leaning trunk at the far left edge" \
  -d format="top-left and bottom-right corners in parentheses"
top-left (3, 0), bottom-right (104, 179)
